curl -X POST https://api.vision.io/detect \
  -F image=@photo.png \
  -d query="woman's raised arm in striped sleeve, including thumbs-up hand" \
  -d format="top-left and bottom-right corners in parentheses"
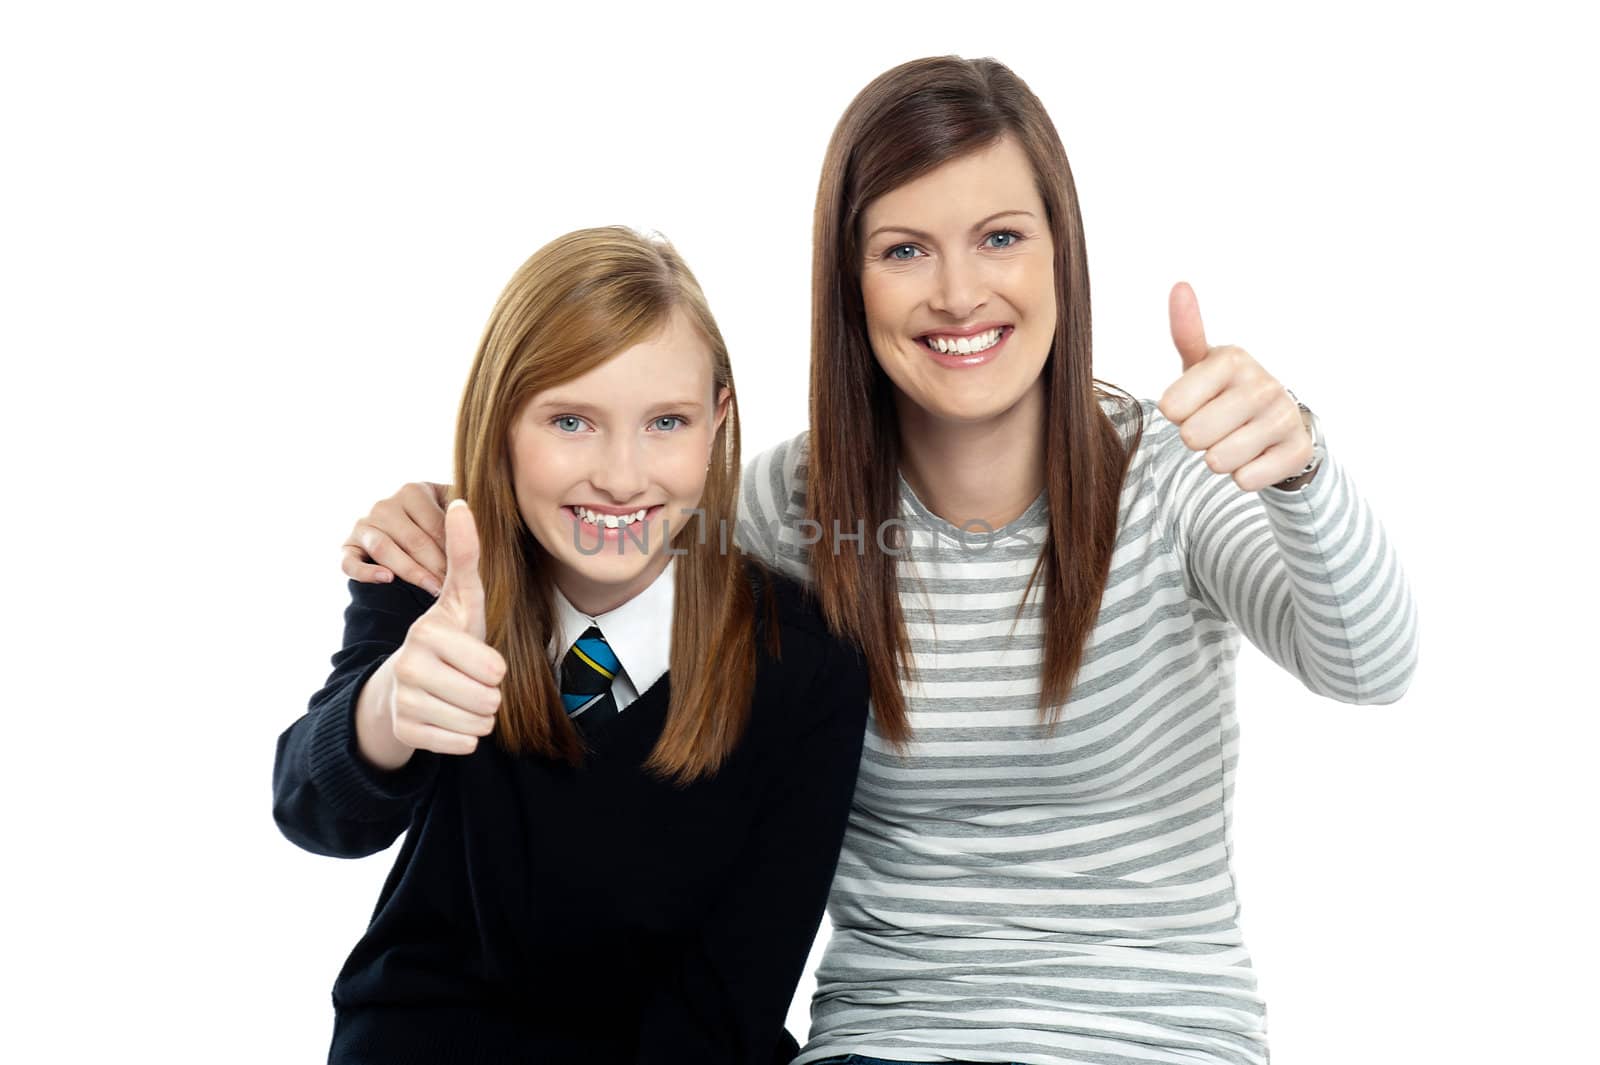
top-left (1146, 281), bottom-right (1416, 702)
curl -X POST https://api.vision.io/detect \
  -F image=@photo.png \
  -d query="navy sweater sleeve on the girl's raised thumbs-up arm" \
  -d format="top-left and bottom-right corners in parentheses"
top-left (272, 580), bottom-right (438, 857)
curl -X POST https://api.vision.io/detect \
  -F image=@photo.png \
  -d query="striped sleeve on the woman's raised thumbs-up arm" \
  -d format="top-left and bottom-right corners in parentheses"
top-left (1146, 405), bottom-right (1418, 704)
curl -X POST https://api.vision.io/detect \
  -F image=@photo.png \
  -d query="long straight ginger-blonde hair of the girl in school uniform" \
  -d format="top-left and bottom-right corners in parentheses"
top-left (454, 225), bottom-right (755, 784)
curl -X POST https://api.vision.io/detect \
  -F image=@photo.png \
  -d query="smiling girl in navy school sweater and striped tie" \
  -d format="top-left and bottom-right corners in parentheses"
top-left (274, 229), bottom-right (866, 1065)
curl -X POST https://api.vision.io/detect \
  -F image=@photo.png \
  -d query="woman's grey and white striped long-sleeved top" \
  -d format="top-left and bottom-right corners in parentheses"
top-left (738, 400), bottom-right (1416, 1065)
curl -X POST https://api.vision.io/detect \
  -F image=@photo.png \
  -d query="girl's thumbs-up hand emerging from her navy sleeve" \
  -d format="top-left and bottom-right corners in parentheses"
top-left (357, 499), bottom-right (506, 769)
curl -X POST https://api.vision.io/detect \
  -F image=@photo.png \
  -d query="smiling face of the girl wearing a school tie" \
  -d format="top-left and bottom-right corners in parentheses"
top-left (510, 309), bottom-right (730, 614)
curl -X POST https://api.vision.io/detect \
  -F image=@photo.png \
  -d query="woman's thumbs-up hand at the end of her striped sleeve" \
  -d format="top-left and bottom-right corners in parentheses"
top-left (1157, 281), bottom-right (1312, 493)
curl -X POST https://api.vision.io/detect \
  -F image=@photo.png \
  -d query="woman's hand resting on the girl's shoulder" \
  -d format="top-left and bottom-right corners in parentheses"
top-left (339, 481), bottom-right (450, 595)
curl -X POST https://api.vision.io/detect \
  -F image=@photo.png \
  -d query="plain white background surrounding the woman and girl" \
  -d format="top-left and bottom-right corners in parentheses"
top-left (0, 2), bottom-right (1600, 1065)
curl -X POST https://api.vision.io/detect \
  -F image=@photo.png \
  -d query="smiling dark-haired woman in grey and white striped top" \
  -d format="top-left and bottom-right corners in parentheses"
top-left (346, 58), bottom-right (1416, 1065)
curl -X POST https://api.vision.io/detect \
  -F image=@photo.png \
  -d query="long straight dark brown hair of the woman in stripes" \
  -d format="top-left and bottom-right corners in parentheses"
top-left (806, 56), bottom-right (1142, 745)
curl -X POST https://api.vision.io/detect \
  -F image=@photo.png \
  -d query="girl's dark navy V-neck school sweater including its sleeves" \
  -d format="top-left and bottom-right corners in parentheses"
top-left (272, 576), bottom-right (867, 1065)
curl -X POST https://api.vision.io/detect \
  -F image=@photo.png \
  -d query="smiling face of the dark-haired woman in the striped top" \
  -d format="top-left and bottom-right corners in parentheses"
top-left (859, 136), bottom-right (1056, 424)
